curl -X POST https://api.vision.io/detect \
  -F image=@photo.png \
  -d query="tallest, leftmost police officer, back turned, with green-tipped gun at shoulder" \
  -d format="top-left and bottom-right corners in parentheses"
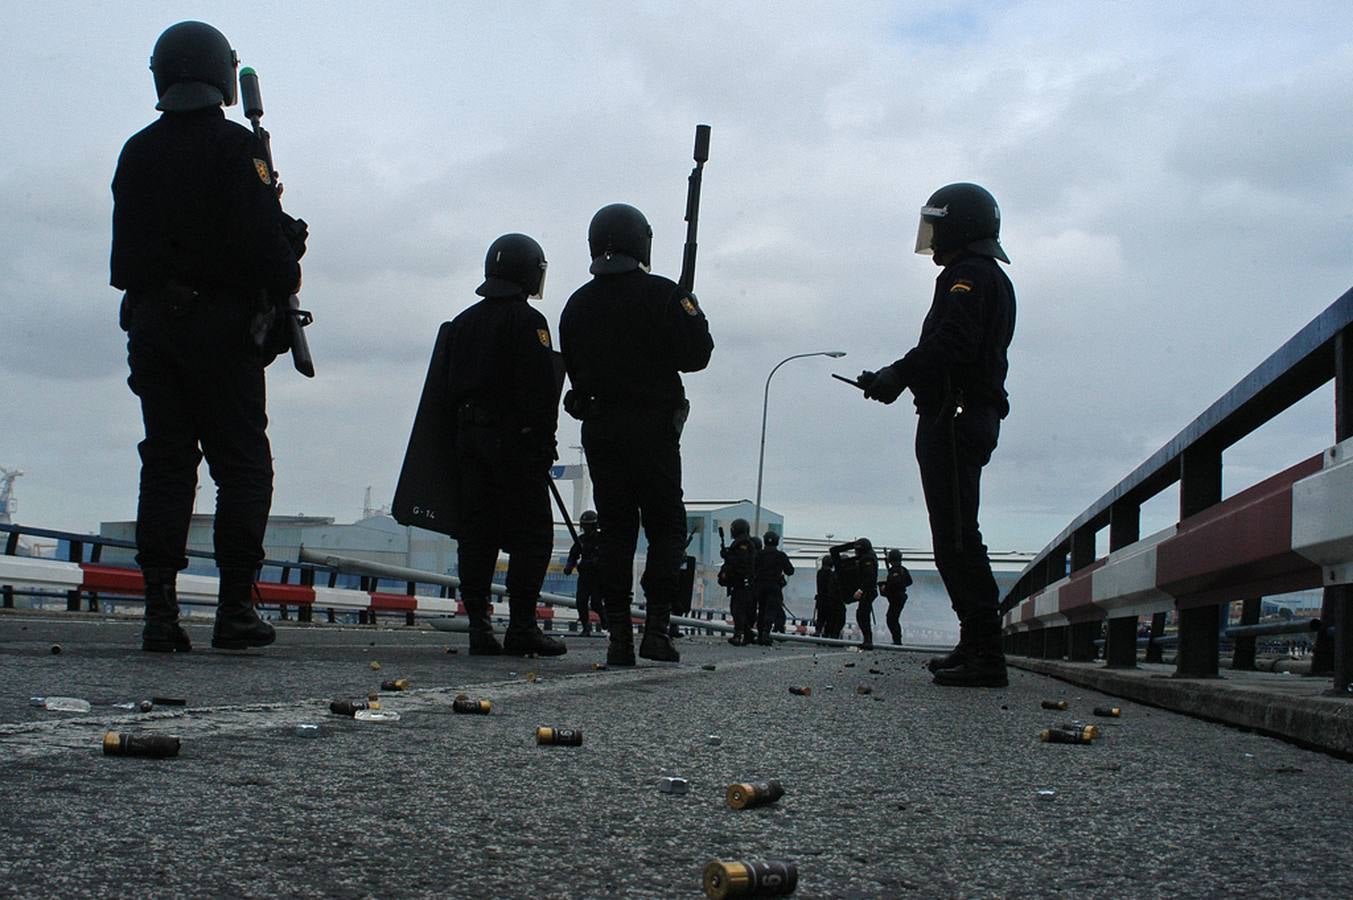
top-left (111, 22), bottom-right (304, 652)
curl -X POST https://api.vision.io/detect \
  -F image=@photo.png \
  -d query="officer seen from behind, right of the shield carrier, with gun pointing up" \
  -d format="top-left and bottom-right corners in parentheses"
top-left (559, 203), bottom-right (714, 666)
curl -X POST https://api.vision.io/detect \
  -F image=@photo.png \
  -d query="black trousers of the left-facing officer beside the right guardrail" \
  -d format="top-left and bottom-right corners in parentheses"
top-left (916, 406), bottom-right (1001, 648)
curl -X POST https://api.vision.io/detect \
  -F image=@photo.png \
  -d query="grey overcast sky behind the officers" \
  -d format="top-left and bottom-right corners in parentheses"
top-left (0, 0), bottom-right (1353, 551)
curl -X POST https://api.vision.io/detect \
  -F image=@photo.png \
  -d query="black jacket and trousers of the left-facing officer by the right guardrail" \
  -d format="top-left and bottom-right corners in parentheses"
top-left (893, 253), bottom-right (1015, 660)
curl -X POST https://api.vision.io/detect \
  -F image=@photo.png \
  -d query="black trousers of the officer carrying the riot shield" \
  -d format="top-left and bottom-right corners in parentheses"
top-left (455, 424), bottom-right (555, 611)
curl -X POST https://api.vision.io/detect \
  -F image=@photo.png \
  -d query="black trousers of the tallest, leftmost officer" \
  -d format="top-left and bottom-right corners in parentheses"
top-left (127, 292), bottom-right (272, 570)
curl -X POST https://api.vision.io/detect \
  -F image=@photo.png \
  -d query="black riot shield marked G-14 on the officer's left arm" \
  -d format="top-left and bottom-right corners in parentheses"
top-left (391, 322), bottom-right (457, 537)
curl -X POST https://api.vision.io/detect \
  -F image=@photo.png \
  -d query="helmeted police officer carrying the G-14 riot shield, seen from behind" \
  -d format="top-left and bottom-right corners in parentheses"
top-left (446, 234), bottom-right (566, 656)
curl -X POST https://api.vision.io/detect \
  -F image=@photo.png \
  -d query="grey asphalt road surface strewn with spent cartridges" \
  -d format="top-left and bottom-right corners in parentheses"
top-left (0, 612), bottom-right (1353, 899)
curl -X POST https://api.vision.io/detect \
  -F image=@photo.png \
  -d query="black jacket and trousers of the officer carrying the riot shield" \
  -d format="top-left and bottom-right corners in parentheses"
top-left (446, 295), bottom-right (560, 605)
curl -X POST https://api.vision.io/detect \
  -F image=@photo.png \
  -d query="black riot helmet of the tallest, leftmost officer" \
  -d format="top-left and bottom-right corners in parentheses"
top-left (150, 22), bottom-right (239, 112)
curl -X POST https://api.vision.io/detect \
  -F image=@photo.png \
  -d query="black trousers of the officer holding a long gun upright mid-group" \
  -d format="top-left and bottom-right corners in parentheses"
top-left (582, 407), bottom-right (686, 627)
